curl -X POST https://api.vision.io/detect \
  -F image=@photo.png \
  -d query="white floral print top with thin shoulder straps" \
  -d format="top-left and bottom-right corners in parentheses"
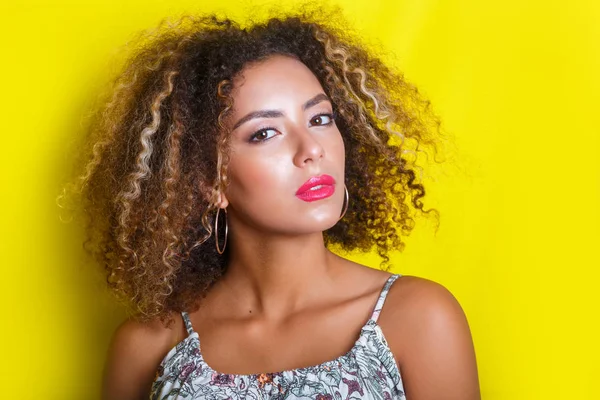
top-left (150, 274), bottom-right (406, 400)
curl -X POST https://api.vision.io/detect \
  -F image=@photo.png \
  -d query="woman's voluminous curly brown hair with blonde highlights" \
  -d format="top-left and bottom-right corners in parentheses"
top-left (62, 11), bottom-right (439, 321)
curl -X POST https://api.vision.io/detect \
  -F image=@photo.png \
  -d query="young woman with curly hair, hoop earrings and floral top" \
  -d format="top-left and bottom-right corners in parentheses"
top-left (70, 12), bottom-right (479, 400)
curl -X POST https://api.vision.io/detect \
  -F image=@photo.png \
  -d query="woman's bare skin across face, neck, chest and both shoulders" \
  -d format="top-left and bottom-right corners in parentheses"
top-left (103, 56), bottom-right (480, 400)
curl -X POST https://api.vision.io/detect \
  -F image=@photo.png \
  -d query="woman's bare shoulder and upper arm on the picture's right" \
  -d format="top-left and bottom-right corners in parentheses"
top-left (380, 276), bottom-right (480, 400)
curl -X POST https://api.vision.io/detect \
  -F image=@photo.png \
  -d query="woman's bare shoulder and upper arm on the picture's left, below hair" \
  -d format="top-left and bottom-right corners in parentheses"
top-left (102, 317), bottom-right (184, 400)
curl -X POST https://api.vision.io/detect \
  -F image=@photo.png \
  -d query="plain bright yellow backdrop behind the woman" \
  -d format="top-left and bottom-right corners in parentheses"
top-left (0, 0), bottom-right (600, 400)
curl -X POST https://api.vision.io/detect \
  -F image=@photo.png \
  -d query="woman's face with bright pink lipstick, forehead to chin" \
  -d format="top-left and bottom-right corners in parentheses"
top-left (222, 56), bottom-right (345, 234)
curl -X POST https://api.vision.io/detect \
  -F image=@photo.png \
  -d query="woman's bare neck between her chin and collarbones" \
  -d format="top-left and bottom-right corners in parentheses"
top-left (219, 232), bottom-right (341, 320)
